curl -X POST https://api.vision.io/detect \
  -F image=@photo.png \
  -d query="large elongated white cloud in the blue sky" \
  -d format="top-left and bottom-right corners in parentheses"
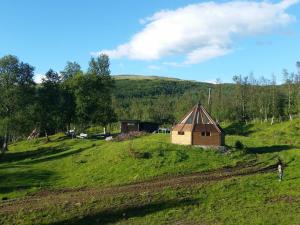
top-left (92, 0), bottom-right (299, 64)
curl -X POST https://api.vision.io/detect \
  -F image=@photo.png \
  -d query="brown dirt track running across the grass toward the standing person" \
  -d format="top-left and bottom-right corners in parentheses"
top-left (0, 165), bottom-right (276, 214)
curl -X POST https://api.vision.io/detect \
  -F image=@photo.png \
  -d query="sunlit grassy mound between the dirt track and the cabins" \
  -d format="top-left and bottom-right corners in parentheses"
top-left (0, 134), bottom-right (242, 198)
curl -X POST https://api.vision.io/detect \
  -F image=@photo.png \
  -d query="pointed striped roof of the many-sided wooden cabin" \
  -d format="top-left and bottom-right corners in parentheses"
top-left (175, 104), bottom-right (222, 133)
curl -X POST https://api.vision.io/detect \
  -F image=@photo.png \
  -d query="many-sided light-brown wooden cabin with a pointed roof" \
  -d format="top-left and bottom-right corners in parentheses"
top-left (171, 104), bottom-right (225, 146)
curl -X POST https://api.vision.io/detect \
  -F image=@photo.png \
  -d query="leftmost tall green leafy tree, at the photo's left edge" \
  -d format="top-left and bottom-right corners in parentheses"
top-left (0, 55), bottom-right (35, 152)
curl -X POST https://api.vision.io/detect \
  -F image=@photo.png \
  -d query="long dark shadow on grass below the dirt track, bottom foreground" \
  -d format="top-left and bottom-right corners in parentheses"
top-left (52, 199), bottom-right (198, 225)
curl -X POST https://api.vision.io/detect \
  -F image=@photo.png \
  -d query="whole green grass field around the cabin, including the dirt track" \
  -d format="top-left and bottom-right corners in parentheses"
top-left (0, 119), bottom-right (300, 224)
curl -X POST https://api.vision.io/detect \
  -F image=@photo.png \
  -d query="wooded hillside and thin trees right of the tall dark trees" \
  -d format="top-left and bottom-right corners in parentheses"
top-left (113, 62), bottom-right (300, 125)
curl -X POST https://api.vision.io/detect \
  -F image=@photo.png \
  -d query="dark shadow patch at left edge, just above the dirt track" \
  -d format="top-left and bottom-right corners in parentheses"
top-left (0, 170), bottom-right (55, 194)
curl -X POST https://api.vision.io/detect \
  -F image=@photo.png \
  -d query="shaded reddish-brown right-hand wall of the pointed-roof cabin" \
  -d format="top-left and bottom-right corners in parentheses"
top-left (193, 132), bottom-right (224, 146)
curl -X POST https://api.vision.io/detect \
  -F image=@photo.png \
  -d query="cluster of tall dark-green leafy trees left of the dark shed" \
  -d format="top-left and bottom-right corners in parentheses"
top-left (0, 55), bottom-right (116, 152)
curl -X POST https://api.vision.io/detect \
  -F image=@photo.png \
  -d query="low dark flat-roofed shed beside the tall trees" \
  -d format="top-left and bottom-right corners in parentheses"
top-left (120, 120), bottom-right (159, 133)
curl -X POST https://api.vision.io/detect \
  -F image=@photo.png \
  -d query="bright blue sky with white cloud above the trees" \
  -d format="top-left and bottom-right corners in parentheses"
top-left (0, 0), bottom-right (300, 82)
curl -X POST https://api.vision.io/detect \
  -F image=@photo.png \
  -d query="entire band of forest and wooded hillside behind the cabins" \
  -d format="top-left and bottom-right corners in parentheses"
top-left (0, 55), bottom-right (300, 152)
